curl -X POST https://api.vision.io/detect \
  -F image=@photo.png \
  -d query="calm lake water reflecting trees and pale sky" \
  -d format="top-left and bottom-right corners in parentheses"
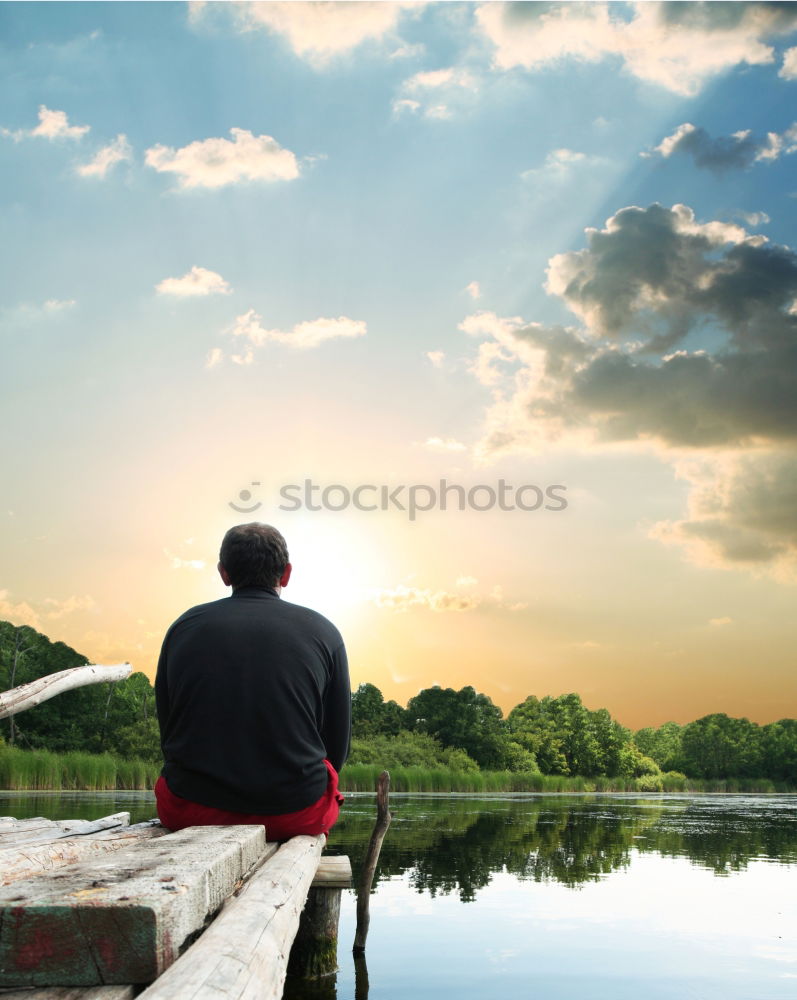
top-left (0, 792), bottom-right (797, 1000)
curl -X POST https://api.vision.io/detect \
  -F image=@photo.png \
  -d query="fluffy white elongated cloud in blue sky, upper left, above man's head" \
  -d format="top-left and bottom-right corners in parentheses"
top-left (144, 128), bottom-right (299, 189)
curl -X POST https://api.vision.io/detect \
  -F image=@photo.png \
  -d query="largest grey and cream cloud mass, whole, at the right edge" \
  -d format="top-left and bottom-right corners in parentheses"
top-left (460, 205), bottom-right (797, 579)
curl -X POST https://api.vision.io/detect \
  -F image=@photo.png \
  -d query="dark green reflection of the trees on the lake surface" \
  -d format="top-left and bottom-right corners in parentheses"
top-left (329, 796), bottom-right (797, 902)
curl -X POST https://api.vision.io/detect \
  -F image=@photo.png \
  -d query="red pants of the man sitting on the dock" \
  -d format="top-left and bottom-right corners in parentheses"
top-left (155, 760), bottom-right (344, 841)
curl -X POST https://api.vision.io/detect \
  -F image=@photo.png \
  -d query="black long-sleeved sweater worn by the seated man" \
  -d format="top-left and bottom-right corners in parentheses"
top-left (155, 587), bottom-right (351, 815)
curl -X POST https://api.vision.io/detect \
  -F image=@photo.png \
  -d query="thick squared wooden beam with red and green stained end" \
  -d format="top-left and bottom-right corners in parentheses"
top-left (0, 826), bottom-right (268, 986)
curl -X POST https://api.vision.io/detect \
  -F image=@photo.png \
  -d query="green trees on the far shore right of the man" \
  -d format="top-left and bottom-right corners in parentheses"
top-left (350, 684), bottom-right (797, 791)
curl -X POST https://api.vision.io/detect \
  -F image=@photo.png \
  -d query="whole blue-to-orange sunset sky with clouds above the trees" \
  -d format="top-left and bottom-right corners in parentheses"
top-left (0, 2), bottom-right (797, 728)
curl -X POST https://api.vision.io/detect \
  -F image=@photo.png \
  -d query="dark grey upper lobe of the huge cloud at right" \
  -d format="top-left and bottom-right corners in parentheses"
top-left (547, 205), bottom-right (797, 353)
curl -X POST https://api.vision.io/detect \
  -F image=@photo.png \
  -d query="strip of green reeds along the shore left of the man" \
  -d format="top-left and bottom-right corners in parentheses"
top-left (0, 747), bottom-right (160, 792)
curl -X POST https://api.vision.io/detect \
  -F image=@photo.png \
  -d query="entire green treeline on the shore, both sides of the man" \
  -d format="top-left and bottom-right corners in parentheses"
top-left (0, 622), bottom-right (797, 791)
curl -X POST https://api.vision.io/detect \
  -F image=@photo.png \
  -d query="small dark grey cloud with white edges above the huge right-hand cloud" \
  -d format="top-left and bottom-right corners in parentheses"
top-left (643, 122), bottom-right (797, 174)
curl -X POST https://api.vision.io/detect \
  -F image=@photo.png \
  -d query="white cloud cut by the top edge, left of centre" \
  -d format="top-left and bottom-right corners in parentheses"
top-left (191, 0), bottom-right (425, 69)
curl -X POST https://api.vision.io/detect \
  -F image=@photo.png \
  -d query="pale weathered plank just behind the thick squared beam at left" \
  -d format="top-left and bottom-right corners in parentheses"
top-left (0, 820), bottom-right (167, 885)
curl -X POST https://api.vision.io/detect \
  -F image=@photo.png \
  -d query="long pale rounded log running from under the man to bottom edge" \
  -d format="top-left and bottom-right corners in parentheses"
top-left (139, 835), bottom-right (325, 1000)
